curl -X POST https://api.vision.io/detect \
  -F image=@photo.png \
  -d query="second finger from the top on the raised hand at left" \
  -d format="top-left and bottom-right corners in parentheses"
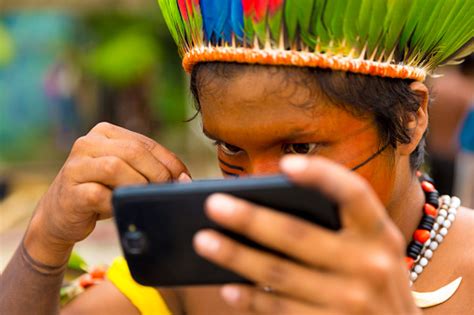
top-left (74, 135), bottom-right (172, 183)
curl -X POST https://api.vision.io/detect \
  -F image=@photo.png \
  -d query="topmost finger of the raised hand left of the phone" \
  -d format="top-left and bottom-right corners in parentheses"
top-left (91, 123), bottom-right (191, 179)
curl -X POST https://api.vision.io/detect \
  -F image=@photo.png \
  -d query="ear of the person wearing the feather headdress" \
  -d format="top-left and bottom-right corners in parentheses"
top-left (398, 82), bottom-right (429, 155)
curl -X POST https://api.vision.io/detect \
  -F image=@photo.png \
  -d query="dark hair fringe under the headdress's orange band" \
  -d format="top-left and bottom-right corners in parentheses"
top-left (190, 62), bottom-right (426, 170)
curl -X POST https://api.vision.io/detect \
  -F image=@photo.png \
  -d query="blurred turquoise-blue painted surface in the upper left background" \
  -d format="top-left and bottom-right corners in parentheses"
top-left (0, 12), bottom-right (74, 159)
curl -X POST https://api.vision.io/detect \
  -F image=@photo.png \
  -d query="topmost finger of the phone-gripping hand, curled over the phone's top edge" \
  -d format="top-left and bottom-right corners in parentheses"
top-left (281, 156), bottom-right (389, 234)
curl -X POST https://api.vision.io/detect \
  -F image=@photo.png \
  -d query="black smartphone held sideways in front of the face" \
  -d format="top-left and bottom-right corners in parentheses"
top-left (113, 176), bottom-right (340, 287)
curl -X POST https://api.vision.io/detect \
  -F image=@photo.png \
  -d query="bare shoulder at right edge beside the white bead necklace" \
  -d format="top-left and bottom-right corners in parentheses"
top-left (414, 207), bottom-right (474, 314)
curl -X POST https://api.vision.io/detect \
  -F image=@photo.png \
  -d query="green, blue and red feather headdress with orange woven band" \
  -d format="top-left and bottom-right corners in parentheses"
top-left (158, 0), bottom-right (474, 81)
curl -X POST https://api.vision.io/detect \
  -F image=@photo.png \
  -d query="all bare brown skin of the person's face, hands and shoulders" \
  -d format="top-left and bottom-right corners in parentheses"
top-left (10, 68), bottom-right (474, 314)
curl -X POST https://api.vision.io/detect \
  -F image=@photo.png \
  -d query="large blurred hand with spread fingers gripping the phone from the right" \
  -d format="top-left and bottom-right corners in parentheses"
top-left (195, 157), bottom-right (419, 315)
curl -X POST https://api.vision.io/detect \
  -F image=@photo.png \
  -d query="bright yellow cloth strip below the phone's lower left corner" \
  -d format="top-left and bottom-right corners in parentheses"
top-left (107, 257), bottom-right (171, 315)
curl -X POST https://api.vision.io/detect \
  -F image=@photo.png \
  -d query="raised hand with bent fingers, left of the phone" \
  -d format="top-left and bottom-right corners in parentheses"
top-left (25, 123), bottom-right (190, 264)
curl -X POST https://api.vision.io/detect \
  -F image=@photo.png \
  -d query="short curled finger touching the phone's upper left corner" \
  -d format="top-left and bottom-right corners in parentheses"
top-left (75, 183), bottom-right (112, 220)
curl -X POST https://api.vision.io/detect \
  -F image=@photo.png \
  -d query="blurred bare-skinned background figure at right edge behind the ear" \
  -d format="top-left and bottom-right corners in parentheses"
top-left (428, 55), bottom-right (474, 201)
